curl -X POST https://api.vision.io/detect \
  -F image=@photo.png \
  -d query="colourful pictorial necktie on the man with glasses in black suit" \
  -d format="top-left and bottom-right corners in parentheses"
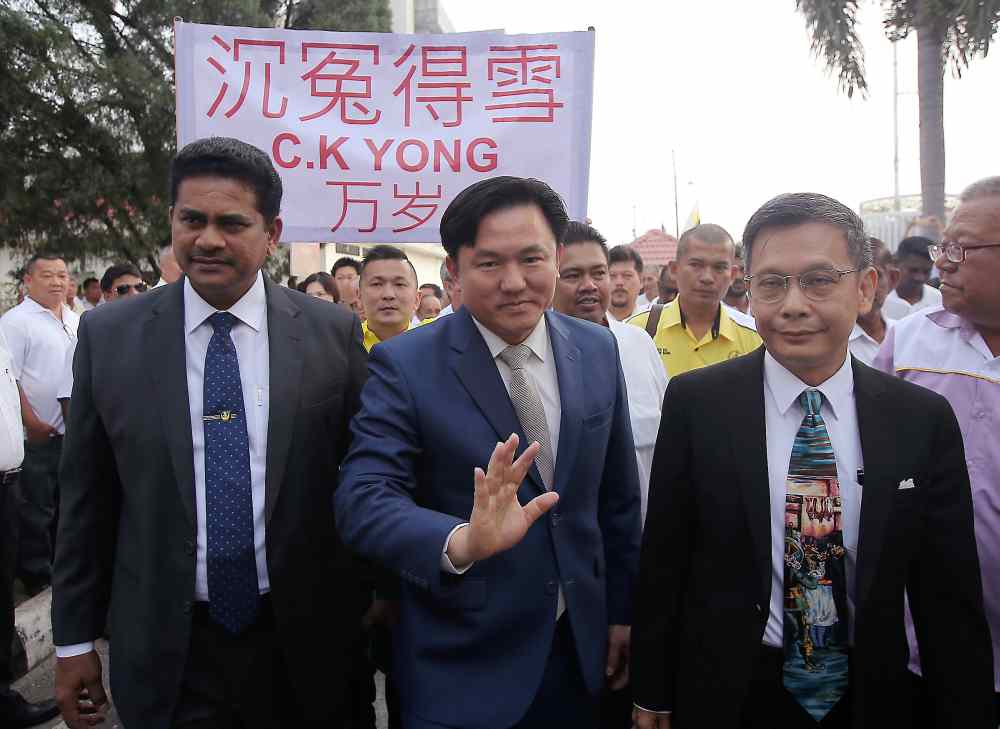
top-left (784, 390), bottom-right (848, 722)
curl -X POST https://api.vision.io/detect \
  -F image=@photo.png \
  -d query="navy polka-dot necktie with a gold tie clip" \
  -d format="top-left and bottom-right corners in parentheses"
top-left (203, 312), bottom-right (258, 634)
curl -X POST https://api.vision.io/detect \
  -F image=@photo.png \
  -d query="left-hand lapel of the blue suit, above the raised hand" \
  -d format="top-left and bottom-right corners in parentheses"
top-left (448, 307), bottom-right (544, 491)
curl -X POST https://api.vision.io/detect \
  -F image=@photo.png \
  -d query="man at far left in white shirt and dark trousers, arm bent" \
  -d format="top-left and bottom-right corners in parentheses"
top-left (0, 254), bottom-right (79, 592)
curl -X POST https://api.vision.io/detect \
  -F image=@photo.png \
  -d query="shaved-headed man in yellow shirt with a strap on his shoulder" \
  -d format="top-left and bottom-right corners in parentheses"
top-left (628, 223), bottom-right (761, 377)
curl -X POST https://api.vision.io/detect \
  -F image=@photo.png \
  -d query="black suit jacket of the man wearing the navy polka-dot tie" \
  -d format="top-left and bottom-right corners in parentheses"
top-left (52, 277), bottom-right (367, 729)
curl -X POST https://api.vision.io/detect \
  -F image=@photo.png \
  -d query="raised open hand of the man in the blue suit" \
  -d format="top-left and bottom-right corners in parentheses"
top-left (448, 434), bottom-right (559, 568)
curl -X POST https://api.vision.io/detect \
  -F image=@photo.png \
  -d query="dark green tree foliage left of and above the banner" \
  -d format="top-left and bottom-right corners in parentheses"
top-left (0, 0), bottom-right (390, 269)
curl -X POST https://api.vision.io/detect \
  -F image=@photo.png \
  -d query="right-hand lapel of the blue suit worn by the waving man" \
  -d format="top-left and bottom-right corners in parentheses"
top-left (545, 310), bottom-right (583, 492)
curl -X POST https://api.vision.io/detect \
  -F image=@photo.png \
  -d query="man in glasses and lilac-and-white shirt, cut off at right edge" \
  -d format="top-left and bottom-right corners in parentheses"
top-left (875, 177), bottom-right (1000, 725)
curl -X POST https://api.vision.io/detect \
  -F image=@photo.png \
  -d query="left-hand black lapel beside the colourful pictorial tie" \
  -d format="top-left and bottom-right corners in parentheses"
top-left (724, 347), bottom-right (771, 605)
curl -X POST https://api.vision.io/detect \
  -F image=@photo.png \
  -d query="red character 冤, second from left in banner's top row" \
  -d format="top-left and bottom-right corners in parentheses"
top-left (299, 43), bottom-right (382, 124)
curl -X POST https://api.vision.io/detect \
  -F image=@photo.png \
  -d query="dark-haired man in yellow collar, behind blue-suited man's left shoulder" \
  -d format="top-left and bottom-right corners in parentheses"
top-left (360, 245), bottom-right (417, 352)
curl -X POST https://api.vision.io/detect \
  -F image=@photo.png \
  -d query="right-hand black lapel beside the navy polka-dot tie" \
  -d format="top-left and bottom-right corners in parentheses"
top-left (264, 276), bottom-right (303, 523)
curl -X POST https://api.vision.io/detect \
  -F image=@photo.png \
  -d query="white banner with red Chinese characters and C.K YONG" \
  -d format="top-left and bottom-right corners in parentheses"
top-left (175, 22), bottom-right (594, 243)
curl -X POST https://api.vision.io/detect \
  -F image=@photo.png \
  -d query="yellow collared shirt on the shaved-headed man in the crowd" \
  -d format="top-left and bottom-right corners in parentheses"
top-left (628, 299), bottom-right (762, 377)
